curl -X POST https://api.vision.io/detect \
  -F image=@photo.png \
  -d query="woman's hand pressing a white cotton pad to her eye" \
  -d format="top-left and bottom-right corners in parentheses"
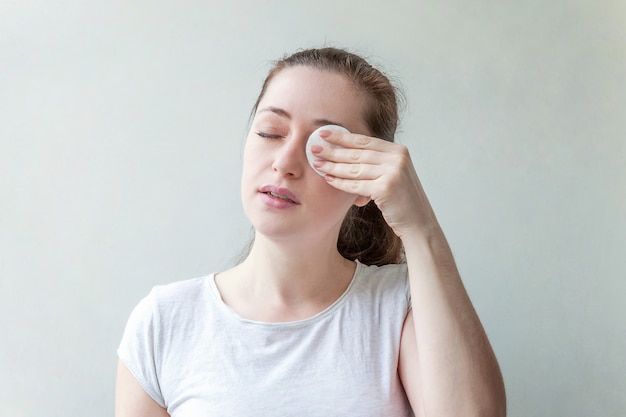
top-left (311, 130), bottom-right (438, 238)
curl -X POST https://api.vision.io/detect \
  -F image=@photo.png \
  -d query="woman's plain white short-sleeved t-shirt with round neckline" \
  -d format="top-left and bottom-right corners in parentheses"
top-left (118, 262), bottom-right (412, 417)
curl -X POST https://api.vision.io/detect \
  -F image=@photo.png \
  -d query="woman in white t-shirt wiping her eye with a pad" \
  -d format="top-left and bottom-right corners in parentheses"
top-left (116, 48), bottom-right (506, 417)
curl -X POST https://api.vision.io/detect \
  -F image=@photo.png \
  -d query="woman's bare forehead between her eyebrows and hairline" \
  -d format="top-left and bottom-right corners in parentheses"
top-left (257, 66), bottom-right (368, 133)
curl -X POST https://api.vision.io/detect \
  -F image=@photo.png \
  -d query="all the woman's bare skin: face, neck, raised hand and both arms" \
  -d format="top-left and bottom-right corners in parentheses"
top-left (116, 67), bottom-right (506, 417)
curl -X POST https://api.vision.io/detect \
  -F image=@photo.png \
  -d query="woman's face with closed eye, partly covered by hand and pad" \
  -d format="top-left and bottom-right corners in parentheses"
top-left (241, 66), bottom-right (370, 241)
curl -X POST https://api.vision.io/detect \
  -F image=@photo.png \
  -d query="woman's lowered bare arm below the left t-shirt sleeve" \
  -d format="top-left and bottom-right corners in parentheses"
top-left (115, 361), bottom-right (169, 417)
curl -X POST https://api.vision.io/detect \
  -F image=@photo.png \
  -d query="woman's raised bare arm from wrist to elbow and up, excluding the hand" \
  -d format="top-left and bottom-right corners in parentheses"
top-left (399, 228), bottom-right (506, 416)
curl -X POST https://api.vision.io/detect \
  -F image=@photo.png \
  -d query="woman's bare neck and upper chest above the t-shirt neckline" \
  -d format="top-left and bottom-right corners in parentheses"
top-left (215, 233), bottom-right (356, 322)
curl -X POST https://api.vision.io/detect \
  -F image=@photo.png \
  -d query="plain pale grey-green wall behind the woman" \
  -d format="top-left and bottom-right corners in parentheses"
top-left (0, 0), bottom-right (626, 417)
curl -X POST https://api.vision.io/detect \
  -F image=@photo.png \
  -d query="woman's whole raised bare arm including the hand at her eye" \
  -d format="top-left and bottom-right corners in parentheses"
top-left (313, 131), bottom-right (506, 417)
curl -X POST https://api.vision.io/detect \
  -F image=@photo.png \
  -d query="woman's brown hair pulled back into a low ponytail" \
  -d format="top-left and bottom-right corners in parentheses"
top-left (252, 48), bottom-right (404, 265)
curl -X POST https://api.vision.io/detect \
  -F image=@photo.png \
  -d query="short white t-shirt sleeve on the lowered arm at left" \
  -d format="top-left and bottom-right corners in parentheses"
top-left (117, 290), bottom-right (165, 407)
